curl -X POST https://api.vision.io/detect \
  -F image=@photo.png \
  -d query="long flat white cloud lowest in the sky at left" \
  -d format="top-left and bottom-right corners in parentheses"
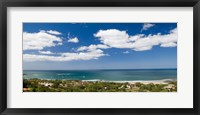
top-left (23, 49), bottom-right (107, 62)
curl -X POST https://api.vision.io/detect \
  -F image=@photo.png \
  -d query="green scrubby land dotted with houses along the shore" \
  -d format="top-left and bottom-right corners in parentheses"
top-left (23, 79), bottom-right (177, 92)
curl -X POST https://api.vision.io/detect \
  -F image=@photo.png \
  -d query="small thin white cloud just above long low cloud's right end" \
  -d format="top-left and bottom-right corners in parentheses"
top-left (78, 44), bottom-right (109, 51)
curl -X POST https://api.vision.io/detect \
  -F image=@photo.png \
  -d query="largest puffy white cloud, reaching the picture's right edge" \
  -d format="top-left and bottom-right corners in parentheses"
top-left (94, 28), bottom-right (178, 51)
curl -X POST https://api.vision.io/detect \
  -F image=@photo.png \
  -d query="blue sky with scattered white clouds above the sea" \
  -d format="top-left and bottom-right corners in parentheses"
top-left (23, 23), bottom-right (178, 70)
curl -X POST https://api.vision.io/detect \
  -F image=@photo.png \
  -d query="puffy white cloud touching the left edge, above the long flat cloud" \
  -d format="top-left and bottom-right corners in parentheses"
top-left (23, 31), bottom-right (62, 50)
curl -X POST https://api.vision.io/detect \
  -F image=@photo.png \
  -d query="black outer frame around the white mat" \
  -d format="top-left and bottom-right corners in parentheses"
top-left (0, 0), bottom-right (200, 115)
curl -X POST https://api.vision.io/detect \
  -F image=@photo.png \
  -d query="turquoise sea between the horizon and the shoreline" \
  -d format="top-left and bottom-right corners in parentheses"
top-left (23, 69), bottom-right (177, 81)
